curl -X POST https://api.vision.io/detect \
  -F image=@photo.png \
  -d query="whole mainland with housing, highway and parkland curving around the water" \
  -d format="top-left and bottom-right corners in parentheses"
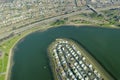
top-left (0, 0), bottom-right (120, 80)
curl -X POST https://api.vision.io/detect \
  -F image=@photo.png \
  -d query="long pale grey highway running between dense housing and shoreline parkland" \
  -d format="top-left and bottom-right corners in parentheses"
top-left (0, 6), bottom-right (120, 40)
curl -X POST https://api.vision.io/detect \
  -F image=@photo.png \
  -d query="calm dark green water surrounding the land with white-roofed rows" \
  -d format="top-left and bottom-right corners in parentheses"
top-left (11, 26), bottom-right (120, 80)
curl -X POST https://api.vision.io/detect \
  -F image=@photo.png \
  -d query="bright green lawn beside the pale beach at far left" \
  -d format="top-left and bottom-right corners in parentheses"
top-left (0, 36), bottom-right (20, 73)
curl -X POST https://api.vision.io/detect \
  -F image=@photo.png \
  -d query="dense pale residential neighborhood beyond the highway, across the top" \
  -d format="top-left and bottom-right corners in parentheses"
top-left (0, 0), bottom-right (120, 27)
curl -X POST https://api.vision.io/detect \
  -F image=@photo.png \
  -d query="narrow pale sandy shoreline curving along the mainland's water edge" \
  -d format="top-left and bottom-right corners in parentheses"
top-left (2, 24), bottom-right (116, 80)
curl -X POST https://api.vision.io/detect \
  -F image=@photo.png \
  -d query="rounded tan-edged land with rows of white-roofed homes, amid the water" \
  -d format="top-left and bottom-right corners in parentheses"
top-left (48, 38), bottom-right (114, 80)
